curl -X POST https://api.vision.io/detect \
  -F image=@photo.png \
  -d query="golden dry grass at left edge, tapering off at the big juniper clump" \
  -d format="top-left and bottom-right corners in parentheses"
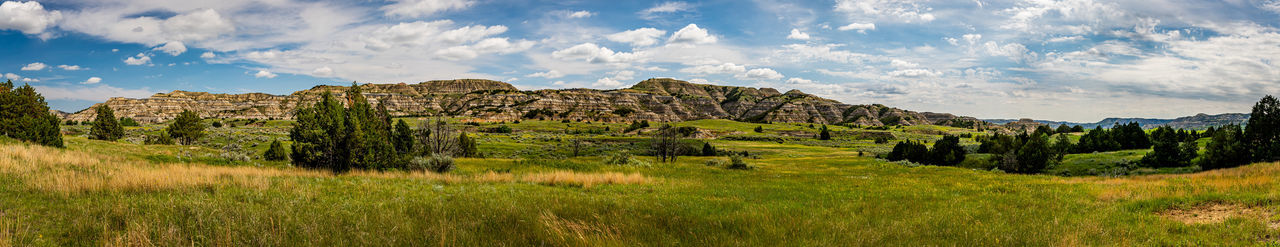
top-left (0, 145), bottom-right (324, 193)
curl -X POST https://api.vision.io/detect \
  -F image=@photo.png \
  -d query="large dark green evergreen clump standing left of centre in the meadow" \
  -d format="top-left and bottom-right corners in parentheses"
top-left (289, 83), bottom-right (479, 173)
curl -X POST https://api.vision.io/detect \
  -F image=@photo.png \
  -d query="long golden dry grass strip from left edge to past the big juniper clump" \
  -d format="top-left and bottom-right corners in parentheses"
top-left (0, 145), bottom-right (648, 195)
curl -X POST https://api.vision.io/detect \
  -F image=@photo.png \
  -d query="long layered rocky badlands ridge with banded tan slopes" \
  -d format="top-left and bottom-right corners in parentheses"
top-left (65, 78), bottom-right (972, 127)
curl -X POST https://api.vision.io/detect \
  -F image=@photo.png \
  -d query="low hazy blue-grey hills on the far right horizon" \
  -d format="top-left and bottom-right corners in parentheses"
top-left (983, 113), bottom-right (1249, 129)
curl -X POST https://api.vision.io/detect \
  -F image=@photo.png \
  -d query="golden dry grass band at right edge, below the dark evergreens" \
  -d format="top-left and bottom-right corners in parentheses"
top-left (1069, 163), bottom-right (1280, 201)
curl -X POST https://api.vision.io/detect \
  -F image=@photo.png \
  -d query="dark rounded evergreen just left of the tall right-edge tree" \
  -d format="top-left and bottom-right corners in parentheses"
top-left (1199, 124), bottom-right (1251, 170)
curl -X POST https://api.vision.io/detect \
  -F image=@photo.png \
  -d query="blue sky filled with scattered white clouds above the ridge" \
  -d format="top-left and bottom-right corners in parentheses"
top-left (0, 0), bottom-right (1280, 122)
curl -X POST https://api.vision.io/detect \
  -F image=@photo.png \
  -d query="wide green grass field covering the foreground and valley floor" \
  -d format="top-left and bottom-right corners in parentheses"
top-left (0, 122), bottom-right (1280, 246)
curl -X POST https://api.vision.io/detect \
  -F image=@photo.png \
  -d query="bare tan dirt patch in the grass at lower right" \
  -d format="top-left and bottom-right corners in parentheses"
top-left (1157, 203), bottom-right (1280, 229)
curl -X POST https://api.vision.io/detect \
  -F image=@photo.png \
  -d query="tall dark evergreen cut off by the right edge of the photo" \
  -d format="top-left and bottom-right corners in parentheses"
top-left (1244, 95), bottom-right (1280, 161)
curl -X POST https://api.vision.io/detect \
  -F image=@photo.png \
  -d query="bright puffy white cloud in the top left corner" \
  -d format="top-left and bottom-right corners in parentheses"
top-left (0, 1), bottom-right (63, 38)
